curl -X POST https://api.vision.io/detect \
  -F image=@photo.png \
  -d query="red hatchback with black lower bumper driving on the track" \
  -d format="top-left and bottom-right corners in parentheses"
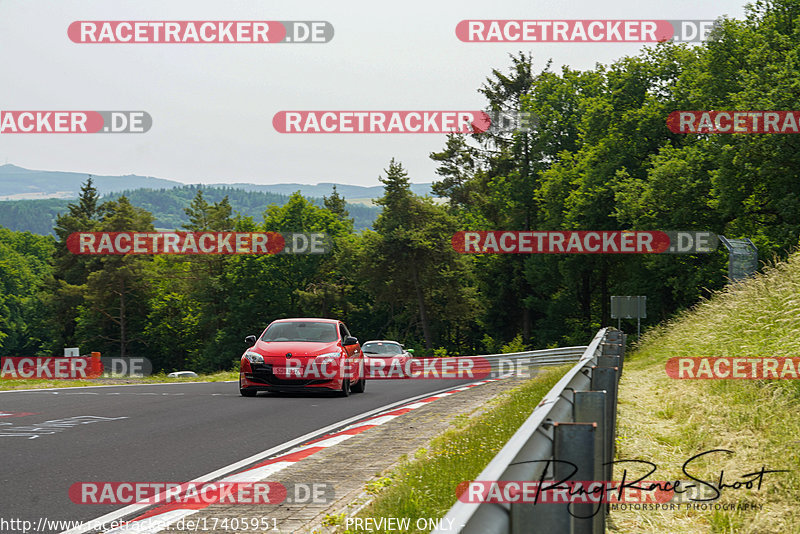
top-left (239, 319), bottom-right (366, 397)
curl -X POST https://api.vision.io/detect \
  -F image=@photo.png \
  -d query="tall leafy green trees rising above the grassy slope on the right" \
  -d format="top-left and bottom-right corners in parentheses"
top-left (431, 0), bottom-right (800, 343)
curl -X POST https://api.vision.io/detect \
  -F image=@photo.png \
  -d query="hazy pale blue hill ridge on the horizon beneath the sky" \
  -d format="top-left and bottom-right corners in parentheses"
top-left (0, 164), bottom-right (431, 201)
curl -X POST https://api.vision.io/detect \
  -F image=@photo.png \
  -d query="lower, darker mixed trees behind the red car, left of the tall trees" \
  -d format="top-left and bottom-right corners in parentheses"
top-left (0, 176), bottom-right (477, 371)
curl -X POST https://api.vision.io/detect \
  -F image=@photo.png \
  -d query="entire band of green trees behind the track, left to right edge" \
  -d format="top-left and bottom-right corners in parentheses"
top-left (0, 0), bottom-right (800, 370)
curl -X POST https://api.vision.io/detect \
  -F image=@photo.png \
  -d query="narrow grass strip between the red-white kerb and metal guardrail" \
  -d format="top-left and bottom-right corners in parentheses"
top-left (346, 366), bottom-right (570, 533)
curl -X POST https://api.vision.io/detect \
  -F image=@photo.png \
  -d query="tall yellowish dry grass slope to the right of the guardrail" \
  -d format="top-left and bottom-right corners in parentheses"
top-left (611, 254), bottom-right (800, 534)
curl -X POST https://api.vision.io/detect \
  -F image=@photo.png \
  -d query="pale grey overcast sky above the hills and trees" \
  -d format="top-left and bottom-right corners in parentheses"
top-left (0, 0), bottom-right (744, 185)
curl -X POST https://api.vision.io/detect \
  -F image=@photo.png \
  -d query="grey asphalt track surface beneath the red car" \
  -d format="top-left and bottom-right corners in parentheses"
top-left (0, 380), bottom-right (476, 533)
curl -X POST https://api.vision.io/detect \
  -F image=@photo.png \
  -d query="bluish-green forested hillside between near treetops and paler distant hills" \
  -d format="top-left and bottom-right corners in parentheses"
top-left (0, 185), bottom-right (379, 235)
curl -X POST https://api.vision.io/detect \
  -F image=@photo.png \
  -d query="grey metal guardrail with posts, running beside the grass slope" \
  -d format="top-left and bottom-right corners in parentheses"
top-left (432, 328), bottom-right (625, 534)
